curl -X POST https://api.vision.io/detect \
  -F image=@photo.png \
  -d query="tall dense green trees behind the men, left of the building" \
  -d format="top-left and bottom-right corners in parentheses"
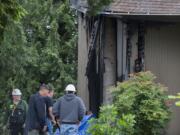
top-left (0, 0), bottom-right (77, 134)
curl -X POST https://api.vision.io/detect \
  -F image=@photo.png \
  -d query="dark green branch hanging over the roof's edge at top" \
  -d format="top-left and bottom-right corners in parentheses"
top-left (88, 0), bottom-right (112, 16)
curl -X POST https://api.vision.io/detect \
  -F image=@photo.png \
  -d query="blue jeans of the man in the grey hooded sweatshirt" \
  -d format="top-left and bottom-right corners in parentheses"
top-left (60, 124), bottom-right (78, 135)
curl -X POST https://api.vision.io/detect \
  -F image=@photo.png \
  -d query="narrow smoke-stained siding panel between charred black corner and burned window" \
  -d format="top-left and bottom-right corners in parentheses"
top-left (103, 18), bottom-right (116, 103)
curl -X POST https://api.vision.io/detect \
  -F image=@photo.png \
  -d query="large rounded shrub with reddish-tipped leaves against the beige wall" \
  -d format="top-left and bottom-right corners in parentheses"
top-left (112, 72), bottom-right (170, 135)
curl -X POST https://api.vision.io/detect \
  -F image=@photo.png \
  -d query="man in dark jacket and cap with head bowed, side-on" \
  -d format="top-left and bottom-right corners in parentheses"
top-left (26, 84), bottom-right (49, 135)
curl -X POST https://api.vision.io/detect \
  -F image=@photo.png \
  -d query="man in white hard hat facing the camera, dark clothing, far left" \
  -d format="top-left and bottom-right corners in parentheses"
top-left (8, 89), bottom-right (28, 135)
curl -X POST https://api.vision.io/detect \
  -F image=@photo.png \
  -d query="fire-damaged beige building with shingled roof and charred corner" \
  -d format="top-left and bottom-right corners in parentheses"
top-left (72, 0), bottom-right (180, 135)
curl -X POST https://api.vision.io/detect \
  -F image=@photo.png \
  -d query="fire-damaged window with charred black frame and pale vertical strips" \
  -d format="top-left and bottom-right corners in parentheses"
top-left (117, 19), bottom-right (145, 81)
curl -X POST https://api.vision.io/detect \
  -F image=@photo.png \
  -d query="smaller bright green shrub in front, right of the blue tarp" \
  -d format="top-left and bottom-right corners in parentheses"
top-left (88, 105), bottom-right (135, 135)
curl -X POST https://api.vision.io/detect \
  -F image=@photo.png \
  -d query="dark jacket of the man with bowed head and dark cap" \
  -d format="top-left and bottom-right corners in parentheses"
top-left (26, 93), bottom-right (46, 131)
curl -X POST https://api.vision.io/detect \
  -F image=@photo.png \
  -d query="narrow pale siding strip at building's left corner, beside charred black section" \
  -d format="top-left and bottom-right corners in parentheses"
top-left (77, 14), bottom-right (89, 108)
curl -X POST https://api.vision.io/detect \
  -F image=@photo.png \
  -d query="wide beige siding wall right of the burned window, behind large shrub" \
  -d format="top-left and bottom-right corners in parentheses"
top-left (145, 24), bottom-right (180, 135)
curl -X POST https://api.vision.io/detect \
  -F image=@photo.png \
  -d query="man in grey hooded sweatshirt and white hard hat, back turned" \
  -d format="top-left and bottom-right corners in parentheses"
top-left (53, 84), bottom-right (86, 135)
